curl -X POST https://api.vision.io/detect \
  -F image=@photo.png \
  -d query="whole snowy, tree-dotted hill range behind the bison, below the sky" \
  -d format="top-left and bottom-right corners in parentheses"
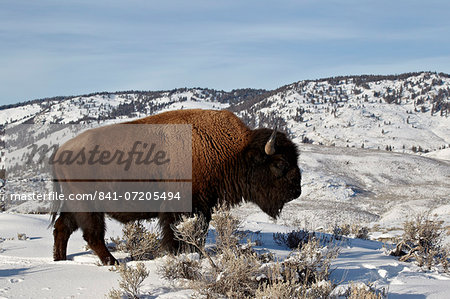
top-left (0, 72), bottom-right (450, 157)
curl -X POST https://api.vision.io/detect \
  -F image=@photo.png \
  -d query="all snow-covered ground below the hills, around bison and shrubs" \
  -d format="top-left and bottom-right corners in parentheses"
top-left (0, 145), bottom-right (450, 299)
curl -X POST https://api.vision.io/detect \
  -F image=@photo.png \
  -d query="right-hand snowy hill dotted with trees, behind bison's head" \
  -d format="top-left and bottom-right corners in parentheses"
top-left (233, 73), bottom-right (450, 152)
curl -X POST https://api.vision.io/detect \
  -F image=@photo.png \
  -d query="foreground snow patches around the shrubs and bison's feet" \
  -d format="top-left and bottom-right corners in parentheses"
top-left (0, 213), bottom-right (450, 298)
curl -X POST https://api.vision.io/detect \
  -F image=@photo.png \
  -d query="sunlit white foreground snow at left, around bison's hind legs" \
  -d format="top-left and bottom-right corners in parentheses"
top-left (0, 213), bottom-right (188, 299)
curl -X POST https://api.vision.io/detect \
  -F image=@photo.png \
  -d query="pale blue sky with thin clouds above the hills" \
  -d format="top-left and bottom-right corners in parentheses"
top-left (0, 0), bottom-right (450, 105)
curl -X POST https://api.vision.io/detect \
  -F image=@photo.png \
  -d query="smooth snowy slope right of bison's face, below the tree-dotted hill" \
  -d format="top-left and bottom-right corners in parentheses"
top-left (234, 144), bottom-right (450, 241)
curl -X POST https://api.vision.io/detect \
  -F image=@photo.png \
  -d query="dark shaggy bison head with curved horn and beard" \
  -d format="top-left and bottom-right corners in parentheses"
top-left (244, 129), bottom-right (301, 218)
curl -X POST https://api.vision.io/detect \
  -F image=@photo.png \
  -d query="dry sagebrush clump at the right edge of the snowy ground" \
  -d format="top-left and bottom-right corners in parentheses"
top-left (390, 212), bottom-right (450, 272)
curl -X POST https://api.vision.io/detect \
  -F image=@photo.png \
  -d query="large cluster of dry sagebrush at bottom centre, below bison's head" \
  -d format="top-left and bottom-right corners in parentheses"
top-left (162, 208), bottom-right (338, 298)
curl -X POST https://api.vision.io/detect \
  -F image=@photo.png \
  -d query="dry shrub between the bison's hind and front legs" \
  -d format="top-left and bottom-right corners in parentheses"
top-left (111, 221), bottom-right (160, 261)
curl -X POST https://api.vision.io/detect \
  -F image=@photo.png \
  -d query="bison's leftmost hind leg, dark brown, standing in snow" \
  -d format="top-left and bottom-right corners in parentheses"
top-left (53, 213), bottom-right (78, 261)
